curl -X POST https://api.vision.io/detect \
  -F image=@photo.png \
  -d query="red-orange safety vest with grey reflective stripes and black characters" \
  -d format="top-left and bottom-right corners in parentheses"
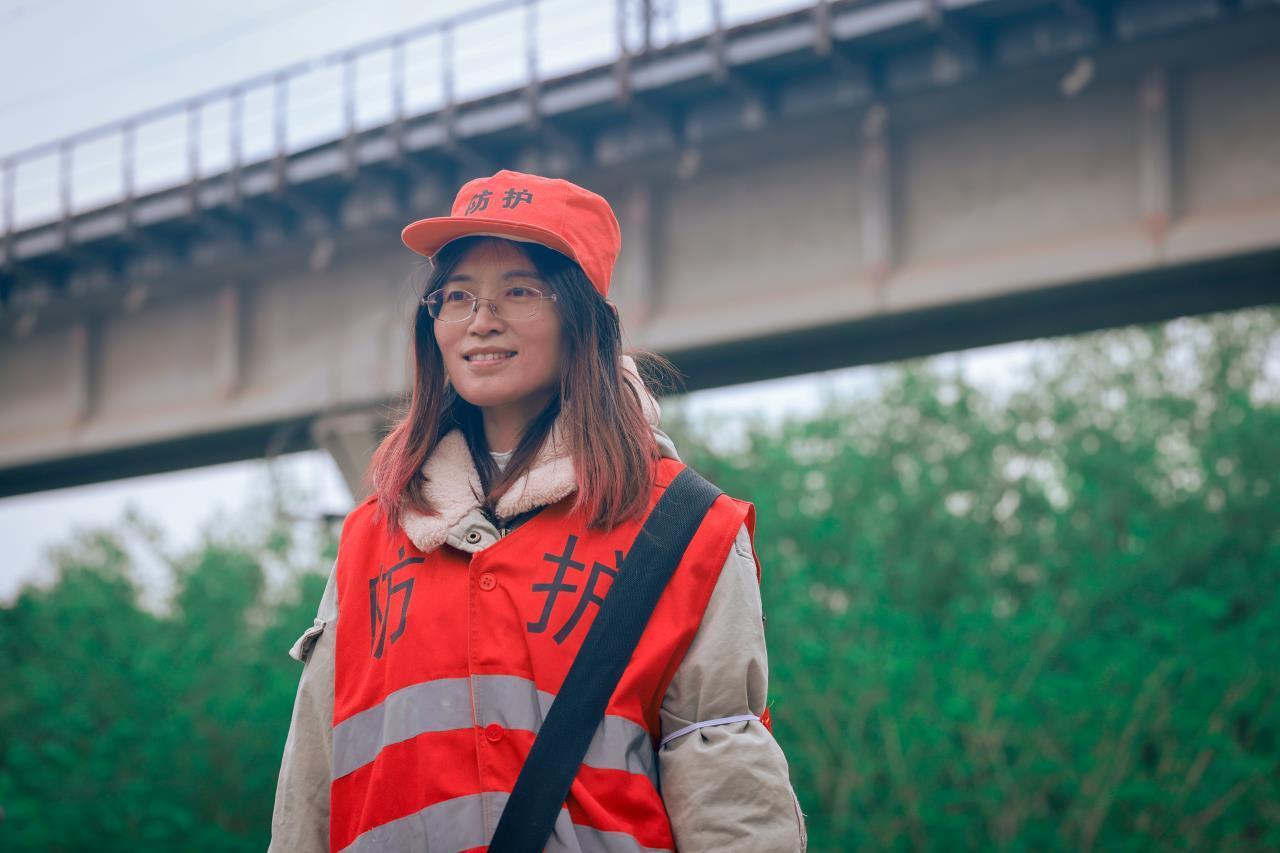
top-left (329, 459), bottom-right (755, 853)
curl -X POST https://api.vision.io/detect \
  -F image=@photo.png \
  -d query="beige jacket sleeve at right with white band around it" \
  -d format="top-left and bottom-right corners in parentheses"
top-left (658, 526), bottom-right (808, 853)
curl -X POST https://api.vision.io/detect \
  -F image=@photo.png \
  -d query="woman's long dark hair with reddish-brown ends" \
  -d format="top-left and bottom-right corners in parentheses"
top-left (369, 237), bottom-right (672, 529)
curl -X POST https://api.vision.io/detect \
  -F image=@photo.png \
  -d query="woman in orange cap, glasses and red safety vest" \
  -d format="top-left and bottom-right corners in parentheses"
top-left (271, 170), bottom-right (805, 853)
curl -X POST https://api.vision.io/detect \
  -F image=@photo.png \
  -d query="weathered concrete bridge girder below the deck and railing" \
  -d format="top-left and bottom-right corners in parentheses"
top-left (0, 0), bottom-right (1280, 496)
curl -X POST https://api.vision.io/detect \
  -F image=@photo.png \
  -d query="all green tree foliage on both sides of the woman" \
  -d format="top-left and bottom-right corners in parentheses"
top-left (0, 303), bottom-right (1280, 852)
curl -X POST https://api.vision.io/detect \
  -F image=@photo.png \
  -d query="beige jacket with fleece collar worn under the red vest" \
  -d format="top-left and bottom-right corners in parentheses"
top-left (270, 371), bottom-right (806, 853)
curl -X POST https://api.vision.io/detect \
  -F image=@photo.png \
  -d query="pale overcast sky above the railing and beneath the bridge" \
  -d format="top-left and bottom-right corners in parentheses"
top-left (0, 0), bottom-right (1029, 602)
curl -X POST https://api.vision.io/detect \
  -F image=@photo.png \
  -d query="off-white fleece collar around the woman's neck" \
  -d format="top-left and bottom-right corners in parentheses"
top-left (401, 356), bottom-right (675, 553)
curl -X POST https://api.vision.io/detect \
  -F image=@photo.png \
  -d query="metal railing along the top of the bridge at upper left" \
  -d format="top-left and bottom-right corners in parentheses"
top-left (0, 0), bottom-right (823, 236)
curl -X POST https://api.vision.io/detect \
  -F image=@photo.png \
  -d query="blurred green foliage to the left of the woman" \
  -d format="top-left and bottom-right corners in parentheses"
top-left (0, 514), bottom-right (332, 853)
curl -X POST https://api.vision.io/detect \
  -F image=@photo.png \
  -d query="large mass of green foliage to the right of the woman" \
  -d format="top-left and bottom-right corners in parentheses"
top-left (682, 310), bottom-right (1280, 850)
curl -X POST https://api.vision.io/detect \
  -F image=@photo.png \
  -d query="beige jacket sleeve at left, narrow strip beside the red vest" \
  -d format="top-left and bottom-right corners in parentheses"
top-left (269, 565), bottom-right (338, 853)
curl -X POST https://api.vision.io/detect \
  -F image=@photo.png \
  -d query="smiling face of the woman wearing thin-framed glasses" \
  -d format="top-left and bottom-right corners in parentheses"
top-left (434, 240), bottom-right (564, 425)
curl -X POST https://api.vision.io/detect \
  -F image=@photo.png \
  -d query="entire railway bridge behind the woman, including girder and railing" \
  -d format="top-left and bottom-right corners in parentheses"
top-left (0, 0), bottom-right (1280, 494)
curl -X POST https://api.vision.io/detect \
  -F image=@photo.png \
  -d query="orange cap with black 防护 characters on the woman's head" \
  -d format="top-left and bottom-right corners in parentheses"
top-left (401, 169), bottom-right (622, 296)
